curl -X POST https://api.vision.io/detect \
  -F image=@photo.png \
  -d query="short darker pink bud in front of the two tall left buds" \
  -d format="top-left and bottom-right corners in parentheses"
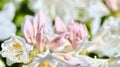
top-left (36, 26), bottom-right (46, 52)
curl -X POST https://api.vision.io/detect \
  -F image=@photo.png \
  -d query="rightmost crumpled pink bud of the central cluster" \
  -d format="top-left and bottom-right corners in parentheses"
top-left (68, 20), bottom-right (88, 49)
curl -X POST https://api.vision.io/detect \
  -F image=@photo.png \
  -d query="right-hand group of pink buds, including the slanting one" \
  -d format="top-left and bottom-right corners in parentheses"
top-left (47, 17), bottom-right (88, 51)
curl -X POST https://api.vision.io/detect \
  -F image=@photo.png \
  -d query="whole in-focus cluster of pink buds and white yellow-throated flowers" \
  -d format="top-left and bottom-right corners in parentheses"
top-left (1, 11), bottom-right (88, 67)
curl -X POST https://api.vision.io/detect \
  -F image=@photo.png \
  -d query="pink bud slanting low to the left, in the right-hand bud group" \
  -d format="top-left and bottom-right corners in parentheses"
top-left (47, 32), bottom-right (69, 49)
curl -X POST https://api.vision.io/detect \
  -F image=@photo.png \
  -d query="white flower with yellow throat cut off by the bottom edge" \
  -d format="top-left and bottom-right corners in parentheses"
top-left (22, 50), bottom-right (58, 67)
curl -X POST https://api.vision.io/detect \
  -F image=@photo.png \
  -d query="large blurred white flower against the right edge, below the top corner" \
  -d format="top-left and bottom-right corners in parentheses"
top-left (88, 17), bottom-right (120, 58)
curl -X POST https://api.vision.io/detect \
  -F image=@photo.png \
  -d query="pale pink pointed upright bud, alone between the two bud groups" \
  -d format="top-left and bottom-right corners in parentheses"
top-left (55, 17), bottom-right (67, 34)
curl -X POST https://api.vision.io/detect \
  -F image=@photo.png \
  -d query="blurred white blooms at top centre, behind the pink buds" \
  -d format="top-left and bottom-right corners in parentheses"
top-left (28, 0), bottom-right (80, 24)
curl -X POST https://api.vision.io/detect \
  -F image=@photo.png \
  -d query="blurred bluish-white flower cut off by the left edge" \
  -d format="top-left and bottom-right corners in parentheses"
top-left (0, 3), bottom-right (16, 40)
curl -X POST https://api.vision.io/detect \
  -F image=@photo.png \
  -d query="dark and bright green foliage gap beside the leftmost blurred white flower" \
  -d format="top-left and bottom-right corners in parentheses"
top-left (13, 0), bottom-right (34, 36)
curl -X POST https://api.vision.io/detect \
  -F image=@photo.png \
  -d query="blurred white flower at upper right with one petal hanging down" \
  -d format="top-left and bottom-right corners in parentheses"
top-left (79, 0), bottom-right (110, 35)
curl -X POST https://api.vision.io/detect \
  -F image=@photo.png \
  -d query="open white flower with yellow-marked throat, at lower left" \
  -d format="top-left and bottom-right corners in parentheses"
top-left (0, 36), bottom-right (32, 65)
